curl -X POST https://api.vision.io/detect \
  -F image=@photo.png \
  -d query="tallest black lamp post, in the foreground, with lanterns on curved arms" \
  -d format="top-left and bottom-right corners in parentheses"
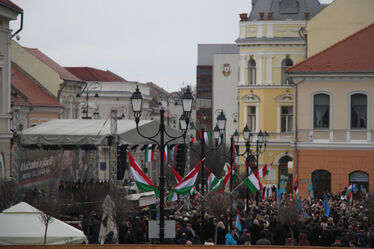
top-left (130, 86), bottom-right (194, 244)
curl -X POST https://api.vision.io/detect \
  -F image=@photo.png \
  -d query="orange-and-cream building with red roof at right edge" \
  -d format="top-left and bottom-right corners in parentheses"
top-left (289, 23), bottom-right (374, 197)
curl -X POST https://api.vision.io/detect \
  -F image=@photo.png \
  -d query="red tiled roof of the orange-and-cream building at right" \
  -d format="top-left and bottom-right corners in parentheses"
top-left (287, 23), bottom-right (374, 73)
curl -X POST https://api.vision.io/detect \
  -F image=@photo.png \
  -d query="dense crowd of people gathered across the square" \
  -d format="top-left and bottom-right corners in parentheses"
top-left (13, 181), bottom-right (374, 245)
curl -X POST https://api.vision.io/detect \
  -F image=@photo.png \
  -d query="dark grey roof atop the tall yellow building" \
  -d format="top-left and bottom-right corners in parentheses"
top-left (249, 0), bottom-right (326, 21)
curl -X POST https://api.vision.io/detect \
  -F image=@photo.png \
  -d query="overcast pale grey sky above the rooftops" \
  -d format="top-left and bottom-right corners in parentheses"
top-left (11, 0), bottom-right (332, 91)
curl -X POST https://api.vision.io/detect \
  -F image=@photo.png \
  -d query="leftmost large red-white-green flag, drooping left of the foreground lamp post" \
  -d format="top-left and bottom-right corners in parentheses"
top-left (127, 152), bottom-right (159, 196)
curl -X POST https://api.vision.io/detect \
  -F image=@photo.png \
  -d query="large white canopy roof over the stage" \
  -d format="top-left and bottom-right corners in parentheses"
top-left (19, 119), bottom-right (188, 146)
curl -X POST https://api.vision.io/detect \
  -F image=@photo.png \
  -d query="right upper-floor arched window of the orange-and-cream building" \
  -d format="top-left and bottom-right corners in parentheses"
top-left (351, 93), bottom-right (367, 129)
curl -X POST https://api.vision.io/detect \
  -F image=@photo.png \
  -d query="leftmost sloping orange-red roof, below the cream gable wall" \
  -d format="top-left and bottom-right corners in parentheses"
top-left (11, 63), bottom-right (62, 107)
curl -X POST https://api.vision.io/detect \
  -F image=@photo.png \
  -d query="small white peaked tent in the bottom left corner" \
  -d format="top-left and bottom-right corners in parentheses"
top-left (0, 202), bottom-right (87, 245)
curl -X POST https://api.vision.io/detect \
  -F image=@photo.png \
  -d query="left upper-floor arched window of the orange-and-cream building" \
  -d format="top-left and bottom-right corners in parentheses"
top-left (313, 93), bottom-right (330, 129)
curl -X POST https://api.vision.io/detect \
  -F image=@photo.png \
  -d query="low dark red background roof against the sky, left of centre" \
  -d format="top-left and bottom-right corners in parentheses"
top-left (65, 67), bottom-right (126, 82)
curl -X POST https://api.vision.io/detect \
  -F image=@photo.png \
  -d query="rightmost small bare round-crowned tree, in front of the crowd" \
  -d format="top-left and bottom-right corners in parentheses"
top-left (278, 199), bottom-right (303, 241)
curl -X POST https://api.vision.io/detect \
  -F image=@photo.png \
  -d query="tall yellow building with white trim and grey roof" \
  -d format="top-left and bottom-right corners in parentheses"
top-left (236, 0), bottom-right (324, 189)
